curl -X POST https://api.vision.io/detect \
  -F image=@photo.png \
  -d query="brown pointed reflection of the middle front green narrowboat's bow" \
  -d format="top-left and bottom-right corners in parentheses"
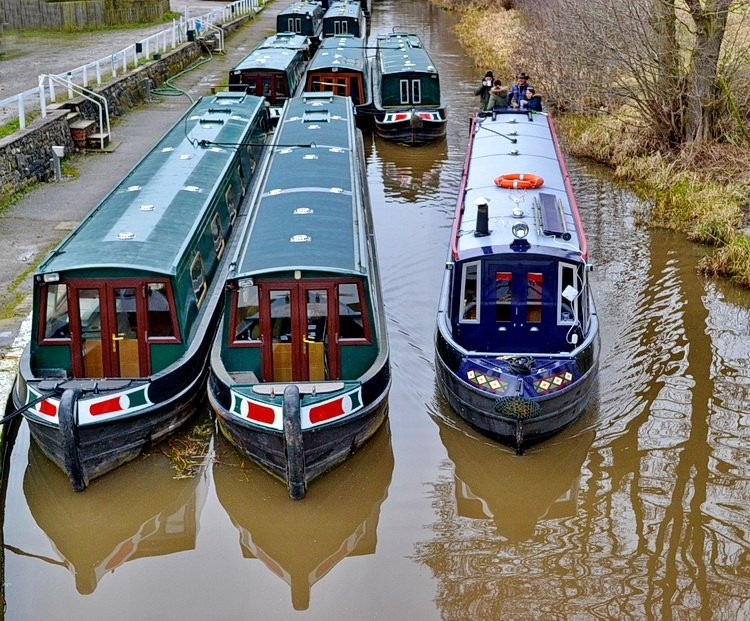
top-left (213, 420), bottom-right (393, 610)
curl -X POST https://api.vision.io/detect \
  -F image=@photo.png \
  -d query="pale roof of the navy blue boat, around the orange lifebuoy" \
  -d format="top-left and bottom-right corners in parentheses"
top-left (452, 110), bottom-right (587, 260)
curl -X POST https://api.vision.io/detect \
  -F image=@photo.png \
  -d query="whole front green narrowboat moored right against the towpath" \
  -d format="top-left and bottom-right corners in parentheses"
top-left (13, 93), bottom-right (267, 491)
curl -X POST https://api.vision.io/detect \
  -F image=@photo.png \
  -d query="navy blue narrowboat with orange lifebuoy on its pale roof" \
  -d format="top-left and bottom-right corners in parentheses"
top-left (436, 110), bottom-right (599, 451)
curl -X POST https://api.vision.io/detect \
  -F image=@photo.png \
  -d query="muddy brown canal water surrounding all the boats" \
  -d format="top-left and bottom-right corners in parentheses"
top-left (3, 0), bottom-right (750, 621)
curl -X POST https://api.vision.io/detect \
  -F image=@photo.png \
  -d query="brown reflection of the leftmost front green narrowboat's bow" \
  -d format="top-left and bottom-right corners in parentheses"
top-left (23, 434), bottom-right (208, 595)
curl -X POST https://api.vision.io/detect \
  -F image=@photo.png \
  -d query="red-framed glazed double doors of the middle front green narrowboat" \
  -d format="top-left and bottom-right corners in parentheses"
top-left (261, 283), bottom-right (339, 382)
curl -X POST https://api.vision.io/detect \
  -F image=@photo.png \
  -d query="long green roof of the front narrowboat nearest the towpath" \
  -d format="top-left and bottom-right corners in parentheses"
top-left (37, 92), bottom-right (264, 275)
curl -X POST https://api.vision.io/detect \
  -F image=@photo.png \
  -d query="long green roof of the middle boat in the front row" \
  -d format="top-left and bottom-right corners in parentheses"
top-left (234, 93), bottom-right (367, 276)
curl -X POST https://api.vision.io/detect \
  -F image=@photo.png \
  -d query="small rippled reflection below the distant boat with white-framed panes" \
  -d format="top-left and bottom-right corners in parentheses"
top-left (368, 140), bottom-right (448, 203)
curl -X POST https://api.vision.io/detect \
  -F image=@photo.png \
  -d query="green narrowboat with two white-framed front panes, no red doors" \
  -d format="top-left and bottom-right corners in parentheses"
top-left (373, 33), bottom-right (447, 145)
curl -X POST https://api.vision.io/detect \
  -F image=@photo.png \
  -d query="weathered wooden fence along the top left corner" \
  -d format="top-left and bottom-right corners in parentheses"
top-left (0, 0), bottom-right (169, 30)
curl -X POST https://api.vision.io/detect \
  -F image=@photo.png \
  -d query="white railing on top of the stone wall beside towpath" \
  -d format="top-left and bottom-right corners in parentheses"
top-left (0, 0), bottom-right (265, 129)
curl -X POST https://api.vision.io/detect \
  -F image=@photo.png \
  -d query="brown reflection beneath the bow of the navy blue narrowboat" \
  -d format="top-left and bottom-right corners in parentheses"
top-left (433, 405), bottom-right (595, 542)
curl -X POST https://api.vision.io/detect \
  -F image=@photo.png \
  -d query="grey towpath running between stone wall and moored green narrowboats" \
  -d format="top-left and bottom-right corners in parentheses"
top-left (0, 5), bottom-right (283, 411)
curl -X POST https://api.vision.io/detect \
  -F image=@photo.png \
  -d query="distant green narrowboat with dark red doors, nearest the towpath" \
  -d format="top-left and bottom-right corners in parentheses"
top-left (229, 33), bottom-right (310, 123)
